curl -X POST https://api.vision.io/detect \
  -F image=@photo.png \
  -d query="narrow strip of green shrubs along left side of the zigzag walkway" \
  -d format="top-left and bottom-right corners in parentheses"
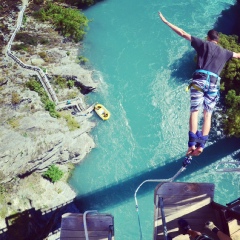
top-left (26, 78), bottom-right (60, 118)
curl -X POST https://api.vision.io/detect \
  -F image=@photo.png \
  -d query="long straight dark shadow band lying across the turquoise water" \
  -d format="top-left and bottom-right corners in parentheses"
top-left (75, 138), bottom-right (240, 212)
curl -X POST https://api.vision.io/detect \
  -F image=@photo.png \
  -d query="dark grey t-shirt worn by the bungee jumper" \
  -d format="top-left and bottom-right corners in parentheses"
top-left (191, 36), bottom-right (233, 75)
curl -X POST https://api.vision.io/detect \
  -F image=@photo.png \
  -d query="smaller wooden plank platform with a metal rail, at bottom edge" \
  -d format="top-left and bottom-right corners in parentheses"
top-left (60, 213), bottom-right (114, 240)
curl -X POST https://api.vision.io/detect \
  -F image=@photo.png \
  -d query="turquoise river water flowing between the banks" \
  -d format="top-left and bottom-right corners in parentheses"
top-left (70, 0), bottom-right (240, 240)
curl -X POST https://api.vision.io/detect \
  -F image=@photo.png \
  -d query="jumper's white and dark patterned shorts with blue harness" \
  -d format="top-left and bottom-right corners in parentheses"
top-left (190, 72), bottom-right (219, 112)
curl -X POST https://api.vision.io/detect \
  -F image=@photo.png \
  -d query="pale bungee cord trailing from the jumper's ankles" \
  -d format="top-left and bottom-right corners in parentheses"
top-left (134, 156), bottom-right (192, 240)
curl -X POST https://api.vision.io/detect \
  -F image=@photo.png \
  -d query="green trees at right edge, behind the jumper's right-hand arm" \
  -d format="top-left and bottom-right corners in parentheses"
top-left (219, 34), bottom-right (240, 137)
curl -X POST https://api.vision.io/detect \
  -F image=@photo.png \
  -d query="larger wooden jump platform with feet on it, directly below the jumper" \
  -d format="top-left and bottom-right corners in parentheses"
top-left (153, 182), bottom-right (222, 240)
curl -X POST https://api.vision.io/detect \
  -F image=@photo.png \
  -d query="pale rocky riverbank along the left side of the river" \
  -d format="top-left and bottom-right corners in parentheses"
top-left (0, 1), bottom-right (97, 236)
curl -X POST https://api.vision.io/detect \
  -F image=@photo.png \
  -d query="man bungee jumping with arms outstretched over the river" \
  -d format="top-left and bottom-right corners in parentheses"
top-left (158, 12), bottom-right (240, 156)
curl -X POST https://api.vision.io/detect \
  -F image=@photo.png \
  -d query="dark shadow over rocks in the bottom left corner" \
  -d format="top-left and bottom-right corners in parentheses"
top-left (0, 200), bottom-right (79, 240)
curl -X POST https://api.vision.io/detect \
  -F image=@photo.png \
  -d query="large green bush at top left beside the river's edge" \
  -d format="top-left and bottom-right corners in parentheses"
top-left (35, 1), bottom-right (89, 42)
